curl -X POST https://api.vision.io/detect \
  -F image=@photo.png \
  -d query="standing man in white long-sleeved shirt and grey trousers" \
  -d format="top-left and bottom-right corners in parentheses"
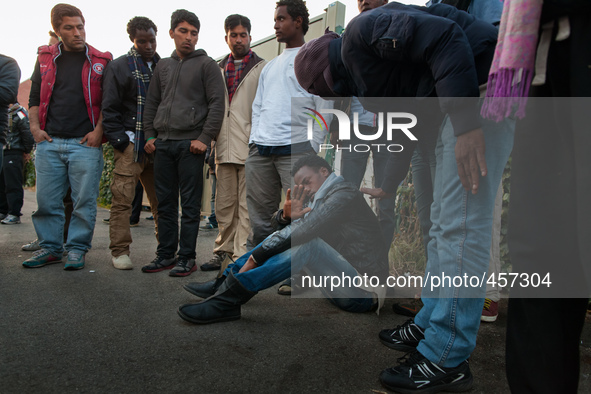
top-left (245, 0), bottom-right (331, 248)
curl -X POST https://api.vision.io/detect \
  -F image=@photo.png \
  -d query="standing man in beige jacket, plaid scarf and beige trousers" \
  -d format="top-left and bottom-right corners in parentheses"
top-left (201, 14), bottom-right (266, 271)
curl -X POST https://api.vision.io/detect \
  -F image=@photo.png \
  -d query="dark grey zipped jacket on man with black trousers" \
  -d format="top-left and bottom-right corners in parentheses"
top-left (144, 49), bottom-right (225, 146)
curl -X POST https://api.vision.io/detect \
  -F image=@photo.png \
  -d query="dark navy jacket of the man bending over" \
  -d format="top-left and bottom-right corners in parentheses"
top-left (329, 2), bottom-right (498, 136)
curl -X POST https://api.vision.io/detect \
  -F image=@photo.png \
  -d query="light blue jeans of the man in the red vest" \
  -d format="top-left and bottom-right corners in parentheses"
top-left (33, 137), bottom-right (103, 256)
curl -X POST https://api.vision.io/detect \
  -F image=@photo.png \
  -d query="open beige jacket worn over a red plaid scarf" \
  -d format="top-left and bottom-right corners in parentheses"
top-left (215, 52), bottom-right (267, 165)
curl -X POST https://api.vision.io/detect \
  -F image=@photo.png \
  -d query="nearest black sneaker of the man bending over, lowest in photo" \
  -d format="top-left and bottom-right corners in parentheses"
top-left (380, 351), bottom-right (473, 394)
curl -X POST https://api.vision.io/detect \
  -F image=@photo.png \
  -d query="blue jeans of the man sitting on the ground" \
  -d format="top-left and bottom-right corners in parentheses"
top-left (224, 238), bottom-right (375, 313)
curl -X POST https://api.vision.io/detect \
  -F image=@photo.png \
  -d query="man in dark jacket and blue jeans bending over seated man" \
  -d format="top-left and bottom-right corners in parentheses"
top-left (296, 2), bottom-right (514, 392)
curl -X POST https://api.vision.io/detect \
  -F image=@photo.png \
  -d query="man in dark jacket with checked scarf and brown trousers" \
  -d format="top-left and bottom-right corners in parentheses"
top-left (103, 16), bottom-right (160, 269)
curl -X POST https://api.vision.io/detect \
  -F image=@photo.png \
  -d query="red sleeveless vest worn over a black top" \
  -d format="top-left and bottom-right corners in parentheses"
top-left (37, 43), bottom-right (113, 130)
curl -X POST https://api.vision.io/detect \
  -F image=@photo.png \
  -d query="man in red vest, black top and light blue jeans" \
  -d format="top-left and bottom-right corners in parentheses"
top-left (23, 4), bottom-right (112, 270)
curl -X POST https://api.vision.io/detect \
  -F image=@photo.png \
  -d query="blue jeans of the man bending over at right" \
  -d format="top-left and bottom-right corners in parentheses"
top-left (415, 113), bottom-right (515, 367)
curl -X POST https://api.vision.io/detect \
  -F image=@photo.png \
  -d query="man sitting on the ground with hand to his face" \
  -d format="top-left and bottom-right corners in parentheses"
top-left (178, 155), bottom-right (388, 324)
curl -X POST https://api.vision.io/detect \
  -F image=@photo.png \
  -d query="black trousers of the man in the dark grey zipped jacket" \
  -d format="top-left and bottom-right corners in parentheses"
top-left (154, 140), bottom-right (205, 259)
